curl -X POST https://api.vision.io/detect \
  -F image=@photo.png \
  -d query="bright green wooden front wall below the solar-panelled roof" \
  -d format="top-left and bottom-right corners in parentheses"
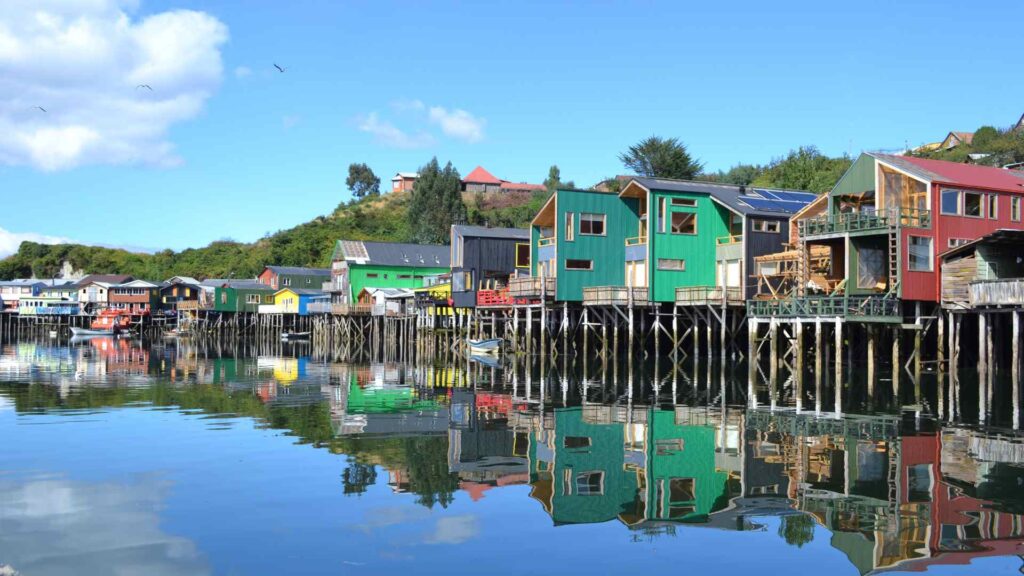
top-left (647, 191), bottom-right (731, 302)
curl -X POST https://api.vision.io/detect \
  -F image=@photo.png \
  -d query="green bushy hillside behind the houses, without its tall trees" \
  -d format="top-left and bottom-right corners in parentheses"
top-left (0, 187), bottom-right (546, 280)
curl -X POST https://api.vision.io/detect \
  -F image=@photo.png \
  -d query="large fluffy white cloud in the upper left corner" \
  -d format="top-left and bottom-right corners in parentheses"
top-left (0, 0), bottom-right (227, 170)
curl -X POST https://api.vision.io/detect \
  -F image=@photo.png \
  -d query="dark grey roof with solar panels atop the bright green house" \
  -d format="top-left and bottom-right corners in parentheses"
top-left (633, 176), bottom-right (818, 217)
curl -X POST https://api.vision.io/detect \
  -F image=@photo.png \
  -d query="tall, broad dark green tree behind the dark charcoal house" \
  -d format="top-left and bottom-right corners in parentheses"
top-left (407, 158), bottom-right (468, 244)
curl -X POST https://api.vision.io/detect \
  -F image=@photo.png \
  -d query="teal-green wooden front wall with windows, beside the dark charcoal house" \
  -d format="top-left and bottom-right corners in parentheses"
top-left (557, 190), bottom-right (640, 301)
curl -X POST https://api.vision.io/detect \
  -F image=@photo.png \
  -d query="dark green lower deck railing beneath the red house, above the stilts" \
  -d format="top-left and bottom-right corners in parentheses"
top-left (746, 295), bottom-right (903, 322)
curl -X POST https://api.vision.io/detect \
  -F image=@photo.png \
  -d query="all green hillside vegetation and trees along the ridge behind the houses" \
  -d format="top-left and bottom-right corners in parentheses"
top-left (0, 139), bottom-right (946, 280)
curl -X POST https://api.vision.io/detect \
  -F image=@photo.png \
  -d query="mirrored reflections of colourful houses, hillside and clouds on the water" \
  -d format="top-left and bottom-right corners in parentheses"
top-left (0, 339), bottom-right (1024, 574)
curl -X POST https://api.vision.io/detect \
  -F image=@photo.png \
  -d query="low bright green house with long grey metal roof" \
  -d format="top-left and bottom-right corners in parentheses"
top-left (324, 240), bottom-right (452, 304)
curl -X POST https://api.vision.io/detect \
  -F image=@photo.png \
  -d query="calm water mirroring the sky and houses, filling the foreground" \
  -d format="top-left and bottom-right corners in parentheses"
top-left (0, 339), bottom-right (1024, 575)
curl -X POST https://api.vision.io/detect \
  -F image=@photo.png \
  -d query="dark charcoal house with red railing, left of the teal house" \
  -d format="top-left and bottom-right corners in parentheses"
top-left (451, 224), bottom-right (530, 307)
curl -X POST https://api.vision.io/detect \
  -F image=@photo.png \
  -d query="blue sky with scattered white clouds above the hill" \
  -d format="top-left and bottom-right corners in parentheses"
top-left (0, 0), bottom-right (1024, 255)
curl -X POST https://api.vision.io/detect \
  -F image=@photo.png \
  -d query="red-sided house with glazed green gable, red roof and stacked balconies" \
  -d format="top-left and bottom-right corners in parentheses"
top-left (750, 153), bottom-right (1024, 322)
